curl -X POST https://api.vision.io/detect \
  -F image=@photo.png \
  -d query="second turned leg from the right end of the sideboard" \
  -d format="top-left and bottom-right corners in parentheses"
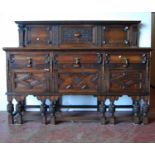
top-left (133, 100), bottom-right (140, 124)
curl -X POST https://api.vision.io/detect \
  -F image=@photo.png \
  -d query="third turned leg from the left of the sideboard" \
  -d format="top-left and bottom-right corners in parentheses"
top-left (40, 100), bottom-right (47, 124)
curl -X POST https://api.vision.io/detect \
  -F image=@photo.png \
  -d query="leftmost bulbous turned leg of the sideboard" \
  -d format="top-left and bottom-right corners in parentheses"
top-left (7, 101), bottom-right (14, 124)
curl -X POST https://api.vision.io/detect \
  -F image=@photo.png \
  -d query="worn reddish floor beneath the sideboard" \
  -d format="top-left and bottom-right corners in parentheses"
top-left (0, 89), bottom-right (155, 143)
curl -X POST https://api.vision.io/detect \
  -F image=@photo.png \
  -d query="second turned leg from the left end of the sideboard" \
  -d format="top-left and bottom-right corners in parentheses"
top-left (16, 101), bottom-right (23, 124)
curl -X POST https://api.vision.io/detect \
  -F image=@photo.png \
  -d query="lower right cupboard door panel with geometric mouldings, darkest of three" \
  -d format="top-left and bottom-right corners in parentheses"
top-left (108, 70), bottom-right (146, 93)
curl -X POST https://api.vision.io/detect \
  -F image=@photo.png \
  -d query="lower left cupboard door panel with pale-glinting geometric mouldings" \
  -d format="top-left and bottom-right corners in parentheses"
top-left (12, 71), bottom-right (49, 93)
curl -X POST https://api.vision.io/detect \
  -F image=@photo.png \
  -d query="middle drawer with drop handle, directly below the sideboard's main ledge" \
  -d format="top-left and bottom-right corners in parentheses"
top-left (54, 51), bottom-right (103, 68)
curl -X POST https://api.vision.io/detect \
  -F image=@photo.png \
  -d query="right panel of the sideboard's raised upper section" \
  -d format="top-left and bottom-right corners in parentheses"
top-left (102, 25), bottom-right (138, 47)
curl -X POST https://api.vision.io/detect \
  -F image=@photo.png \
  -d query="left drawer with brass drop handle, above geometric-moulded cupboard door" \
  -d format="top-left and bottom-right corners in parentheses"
top-left (9, 52), bottom-right (50, 70)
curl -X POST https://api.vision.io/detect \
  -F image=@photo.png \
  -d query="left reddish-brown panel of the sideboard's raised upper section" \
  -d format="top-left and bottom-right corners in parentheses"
top-left (25, 25), bottom-right (53, 47)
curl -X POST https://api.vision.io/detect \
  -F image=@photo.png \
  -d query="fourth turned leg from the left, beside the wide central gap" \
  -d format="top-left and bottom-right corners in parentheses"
top-left (49, 100), bottom-right (56, 125)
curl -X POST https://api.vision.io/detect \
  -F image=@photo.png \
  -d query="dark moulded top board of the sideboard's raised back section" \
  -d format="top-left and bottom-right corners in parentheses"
top-left (15, 20), bottom-right (141, 25)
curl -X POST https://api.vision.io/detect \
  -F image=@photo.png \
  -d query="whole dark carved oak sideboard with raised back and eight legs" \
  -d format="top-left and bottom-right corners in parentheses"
top-left (3, 21), bottom-right (151, 124)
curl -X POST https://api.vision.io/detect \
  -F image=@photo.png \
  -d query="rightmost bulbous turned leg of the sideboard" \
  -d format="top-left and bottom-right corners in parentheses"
top-left (142, 101), bottom-right (149, 124)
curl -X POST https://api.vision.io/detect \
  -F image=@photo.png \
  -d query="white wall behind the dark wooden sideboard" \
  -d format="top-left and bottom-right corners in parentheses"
top-left (0, 0), bottom-right (151, 110)
